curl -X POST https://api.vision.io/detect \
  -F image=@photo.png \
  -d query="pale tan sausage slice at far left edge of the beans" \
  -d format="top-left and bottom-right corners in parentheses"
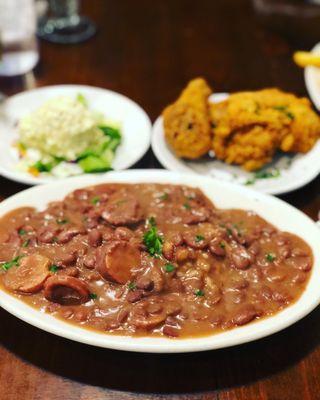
top-left (3, 254), bottom-right (50, 293)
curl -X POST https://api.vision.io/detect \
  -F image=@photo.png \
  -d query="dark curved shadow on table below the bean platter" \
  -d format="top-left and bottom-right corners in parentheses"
top-left (0, 308), bottom-right (320, 393)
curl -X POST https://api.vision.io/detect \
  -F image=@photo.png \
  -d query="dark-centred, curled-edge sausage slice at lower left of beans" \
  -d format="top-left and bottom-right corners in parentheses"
top-left (44, 275), bottom-right (90, 305)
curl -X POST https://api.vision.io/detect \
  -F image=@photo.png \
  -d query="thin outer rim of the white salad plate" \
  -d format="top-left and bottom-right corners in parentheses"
top-left (0, 84), bottom-right (152, 185)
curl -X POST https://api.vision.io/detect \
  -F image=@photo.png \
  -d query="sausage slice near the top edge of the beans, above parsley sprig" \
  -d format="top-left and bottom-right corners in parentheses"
top-left (101, 196), bottom-right (142, 226)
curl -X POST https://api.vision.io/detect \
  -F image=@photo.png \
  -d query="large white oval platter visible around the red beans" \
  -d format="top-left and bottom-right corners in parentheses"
top-left (0, 170), bottom-right (320, 353)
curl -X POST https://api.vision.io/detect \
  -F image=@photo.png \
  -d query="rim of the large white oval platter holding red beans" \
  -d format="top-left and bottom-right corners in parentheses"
top-left (0, 169), bottom-right (320, 353)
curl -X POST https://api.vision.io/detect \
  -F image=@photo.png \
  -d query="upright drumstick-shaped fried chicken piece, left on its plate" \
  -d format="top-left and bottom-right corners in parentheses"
top-left (163, 78), bottom-right (211, 159)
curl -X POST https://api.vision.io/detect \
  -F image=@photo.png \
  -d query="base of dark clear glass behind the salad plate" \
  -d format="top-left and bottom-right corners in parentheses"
top-left (37, 0), bottom-right (96, 44)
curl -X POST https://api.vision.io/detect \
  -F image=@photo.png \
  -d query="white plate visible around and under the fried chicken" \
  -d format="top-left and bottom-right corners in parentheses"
top-left (151, 93), bottom-right (320, 194)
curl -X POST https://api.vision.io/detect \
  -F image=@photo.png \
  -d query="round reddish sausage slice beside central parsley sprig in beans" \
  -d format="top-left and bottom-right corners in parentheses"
top-left (97, 240), bottom-right (141, 284)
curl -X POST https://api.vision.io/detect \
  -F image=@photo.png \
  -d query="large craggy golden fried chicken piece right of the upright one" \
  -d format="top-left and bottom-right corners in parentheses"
top-left (210, 89), bottom-right (320, 171)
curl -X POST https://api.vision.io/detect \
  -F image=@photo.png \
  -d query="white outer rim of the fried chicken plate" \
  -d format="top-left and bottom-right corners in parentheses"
top-left (151, 92), bottom-right (320, 195)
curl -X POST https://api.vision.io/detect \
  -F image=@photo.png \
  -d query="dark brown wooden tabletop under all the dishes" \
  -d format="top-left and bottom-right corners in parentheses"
top-left (0, 0), bottom-right (320, 400)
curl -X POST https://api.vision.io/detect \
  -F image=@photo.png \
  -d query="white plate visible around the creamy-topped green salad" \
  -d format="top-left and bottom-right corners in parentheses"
top-left (0, 85), bottom-right (151, 185)
